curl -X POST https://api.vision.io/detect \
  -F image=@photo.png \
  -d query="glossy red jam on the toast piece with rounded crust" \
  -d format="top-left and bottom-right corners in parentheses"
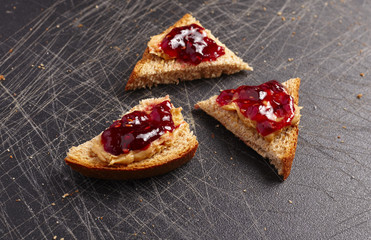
top-left (101, 100), bottom-right (175, 156)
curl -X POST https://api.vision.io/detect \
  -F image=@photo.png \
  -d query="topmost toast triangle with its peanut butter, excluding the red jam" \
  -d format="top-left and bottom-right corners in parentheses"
top-left (125, 14), bottom-right (253, 90)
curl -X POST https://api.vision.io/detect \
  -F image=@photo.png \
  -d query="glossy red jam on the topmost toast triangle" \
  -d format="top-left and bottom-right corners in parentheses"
top-left (160, 24), bottom-right (225, 65)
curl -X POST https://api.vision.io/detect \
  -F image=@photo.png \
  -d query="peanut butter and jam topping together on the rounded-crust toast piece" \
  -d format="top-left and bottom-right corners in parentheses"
top-left (92, 101), bottom-right (184, 165)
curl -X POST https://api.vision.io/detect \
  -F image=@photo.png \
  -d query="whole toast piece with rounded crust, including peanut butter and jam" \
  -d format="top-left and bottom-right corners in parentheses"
top-left (65, 96), bottom-right (198, 180)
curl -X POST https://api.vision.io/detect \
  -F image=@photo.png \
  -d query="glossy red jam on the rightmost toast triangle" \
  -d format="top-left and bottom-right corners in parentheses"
top-left (216, 80), bottom-right (295, 136)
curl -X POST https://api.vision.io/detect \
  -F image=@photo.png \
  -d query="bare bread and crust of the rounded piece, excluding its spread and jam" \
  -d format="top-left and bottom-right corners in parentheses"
top-left (65, 97), bottom-right (198, 180)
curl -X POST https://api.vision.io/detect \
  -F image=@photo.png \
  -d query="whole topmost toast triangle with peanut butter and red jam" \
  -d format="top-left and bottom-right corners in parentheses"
top-left (125, 14), bottom-right (253, 90)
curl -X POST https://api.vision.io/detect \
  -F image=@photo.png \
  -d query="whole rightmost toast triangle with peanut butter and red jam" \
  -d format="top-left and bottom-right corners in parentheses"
top-left (195, 78), bottom-right (301, 180)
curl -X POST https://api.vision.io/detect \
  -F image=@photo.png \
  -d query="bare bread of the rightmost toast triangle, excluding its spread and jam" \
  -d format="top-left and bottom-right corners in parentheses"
top-left (195, 78), bottom-right (300, 180)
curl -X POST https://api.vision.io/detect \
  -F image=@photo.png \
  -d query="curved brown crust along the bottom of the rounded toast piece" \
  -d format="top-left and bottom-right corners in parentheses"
top-left (65, 143), bottom-right (198, 180)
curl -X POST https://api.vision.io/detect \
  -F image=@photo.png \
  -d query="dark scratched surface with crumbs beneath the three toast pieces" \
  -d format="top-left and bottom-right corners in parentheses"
top-left (0, 0), bottom-right (371, 240)
